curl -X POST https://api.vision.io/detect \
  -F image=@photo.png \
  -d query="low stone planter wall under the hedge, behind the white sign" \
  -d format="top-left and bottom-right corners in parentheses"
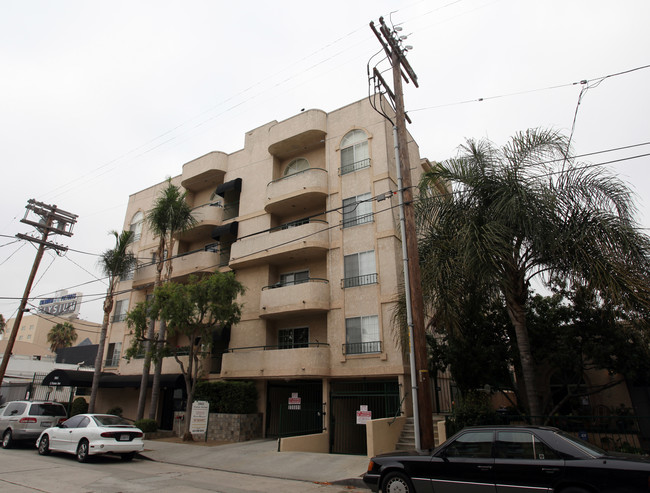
top-left (174, 412), bottom-right (262, 442)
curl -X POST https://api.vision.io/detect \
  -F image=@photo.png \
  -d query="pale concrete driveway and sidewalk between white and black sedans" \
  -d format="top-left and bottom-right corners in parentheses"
top-left (140, 440), bottom-right (368, 488)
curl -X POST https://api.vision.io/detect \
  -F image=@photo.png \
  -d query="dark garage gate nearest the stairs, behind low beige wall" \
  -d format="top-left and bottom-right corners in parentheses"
top-left (330, 379), bottom-right (400, 455)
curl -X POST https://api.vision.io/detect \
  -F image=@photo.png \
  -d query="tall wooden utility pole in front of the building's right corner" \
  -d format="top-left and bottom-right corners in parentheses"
top-left (370, 17), bottom-right (435, 449)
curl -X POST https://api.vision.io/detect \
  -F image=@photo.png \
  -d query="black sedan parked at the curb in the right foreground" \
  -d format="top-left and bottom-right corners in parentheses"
top-left (363, 426), bottom-right (650, 493)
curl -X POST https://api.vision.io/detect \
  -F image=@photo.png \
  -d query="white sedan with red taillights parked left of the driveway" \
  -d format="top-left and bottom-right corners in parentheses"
top-left (36, 414), bottom-right (144, 462)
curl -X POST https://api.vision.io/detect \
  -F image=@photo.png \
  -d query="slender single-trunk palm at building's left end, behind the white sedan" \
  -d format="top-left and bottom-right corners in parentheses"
top-left (88, 231), bottom-right (138, 413)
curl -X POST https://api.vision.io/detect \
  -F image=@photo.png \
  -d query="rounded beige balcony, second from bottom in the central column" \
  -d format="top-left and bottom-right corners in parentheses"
top-left (260, 278), bottom-right (330, 318)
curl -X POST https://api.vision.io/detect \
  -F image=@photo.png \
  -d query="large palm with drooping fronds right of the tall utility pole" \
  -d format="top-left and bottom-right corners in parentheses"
top-left (417, 129), bottom-right (650, 416)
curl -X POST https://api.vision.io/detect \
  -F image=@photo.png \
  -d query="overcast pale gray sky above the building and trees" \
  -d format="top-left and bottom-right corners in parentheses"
top-left (0, 0), bottom-right (650, 322)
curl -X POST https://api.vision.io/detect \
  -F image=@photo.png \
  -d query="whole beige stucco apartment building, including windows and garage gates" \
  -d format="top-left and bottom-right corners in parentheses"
top-left (98, 100), bottom-right (428, 452)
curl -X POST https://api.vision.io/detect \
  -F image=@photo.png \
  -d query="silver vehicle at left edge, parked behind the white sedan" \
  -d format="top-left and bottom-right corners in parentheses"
top-left (0, 401), bottom-right (68, 448)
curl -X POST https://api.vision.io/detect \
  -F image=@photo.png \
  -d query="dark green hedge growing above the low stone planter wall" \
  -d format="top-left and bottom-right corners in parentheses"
top-left (194, 381), bottom-right (257, 414)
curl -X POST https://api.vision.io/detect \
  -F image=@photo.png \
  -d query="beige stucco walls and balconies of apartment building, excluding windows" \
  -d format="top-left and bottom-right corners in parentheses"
top-left (106, 99), bottom-right (424, 436)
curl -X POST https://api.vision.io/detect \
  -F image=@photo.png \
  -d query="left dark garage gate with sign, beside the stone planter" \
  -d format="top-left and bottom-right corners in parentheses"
top-left (266, 380), bottom-right (323, 437)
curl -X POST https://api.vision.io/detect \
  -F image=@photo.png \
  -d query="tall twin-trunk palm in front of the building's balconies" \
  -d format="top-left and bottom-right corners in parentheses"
top-left (136, 180), bottom-right (196, 419)
